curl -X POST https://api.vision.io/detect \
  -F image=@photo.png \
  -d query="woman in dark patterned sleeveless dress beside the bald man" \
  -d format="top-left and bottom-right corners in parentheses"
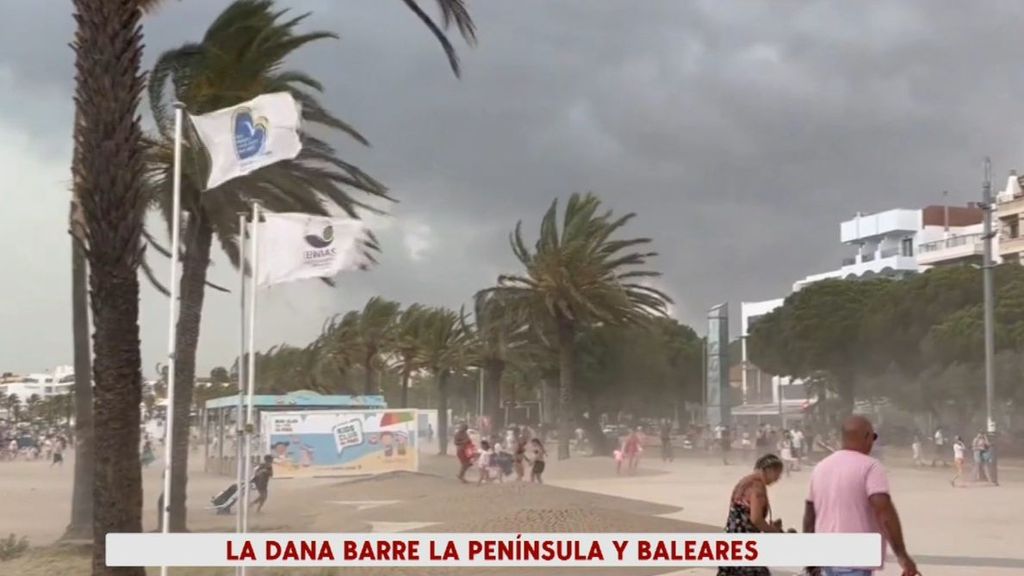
top-left (718, 454), bottom-right (783, 576)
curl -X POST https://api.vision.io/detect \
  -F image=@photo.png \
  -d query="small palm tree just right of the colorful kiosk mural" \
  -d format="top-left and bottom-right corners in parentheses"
top-left (422, 307), bottom-right (466, 455)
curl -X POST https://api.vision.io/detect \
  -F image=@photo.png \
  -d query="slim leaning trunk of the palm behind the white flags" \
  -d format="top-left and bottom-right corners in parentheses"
top-left (170, 212), bottom-right (213, 532)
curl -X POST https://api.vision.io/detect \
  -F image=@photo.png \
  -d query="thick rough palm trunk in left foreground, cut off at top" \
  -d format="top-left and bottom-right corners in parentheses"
top-left (73, 0), bottom-right (146, 576)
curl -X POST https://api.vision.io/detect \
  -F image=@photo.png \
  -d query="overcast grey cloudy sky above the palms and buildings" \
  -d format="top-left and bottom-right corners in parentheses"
top-left (0, 0), bottom-right (1024, 374)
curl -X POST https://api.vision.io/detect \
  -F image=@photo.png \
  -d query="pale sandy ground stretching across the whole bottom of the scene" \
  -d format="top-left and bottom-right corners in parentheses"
top-left (0, 444), bottom-right (1024, 576)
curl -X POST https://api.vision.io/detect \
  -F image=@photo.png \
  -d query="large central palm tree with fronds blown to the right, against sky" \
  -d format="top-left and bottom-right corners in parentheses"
top-left (495, 194), bottom-right (672, 459)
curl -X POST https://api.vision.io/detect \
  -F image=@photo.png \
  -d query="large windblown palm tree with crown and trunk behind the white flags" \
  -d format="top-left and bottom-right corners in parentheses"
top-left (147, 0), bottom-right (388, 531)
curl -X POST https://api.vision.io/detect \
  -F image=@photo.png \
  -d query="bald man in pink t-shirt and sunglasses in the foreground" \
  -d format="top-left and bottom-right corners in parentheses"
top-left (804, 416), bottom-right (920, 576)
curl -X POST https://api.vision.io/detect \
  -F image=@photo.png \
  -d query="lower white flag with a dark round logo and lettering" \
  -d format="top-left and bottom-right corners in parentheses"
top-left (257, 213), bottom-right (368, 286)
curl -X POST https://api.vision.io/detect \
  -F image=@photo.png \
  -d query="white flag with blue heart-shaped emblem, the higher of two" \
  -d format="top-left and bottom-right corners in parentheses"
top-left (191, 92), bottom-right (302, 190)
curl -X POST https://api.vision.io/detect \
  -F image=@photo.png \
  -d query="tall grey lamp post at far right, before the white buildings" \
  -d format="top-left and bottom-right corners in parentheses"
top-left (981, 158), bottom-right (999, 484)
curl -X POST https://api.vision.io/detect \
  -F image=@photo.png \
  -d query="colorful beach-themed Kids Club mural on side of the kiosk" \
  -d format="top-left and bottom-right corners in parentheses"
top-left (260, 410), bottom-right (419, 478)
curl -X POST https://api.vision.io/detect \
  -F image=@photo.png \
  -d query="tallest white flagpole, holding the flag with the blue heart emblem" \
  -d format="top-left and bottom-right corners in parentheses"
top-left (160, 102), bottom-right (185, 576)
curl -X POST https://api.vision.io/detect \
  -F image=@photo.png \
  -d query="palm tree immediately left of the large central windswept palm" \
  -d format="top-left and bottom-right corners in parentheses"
top-left (465, 290), bottom-right (527, 430)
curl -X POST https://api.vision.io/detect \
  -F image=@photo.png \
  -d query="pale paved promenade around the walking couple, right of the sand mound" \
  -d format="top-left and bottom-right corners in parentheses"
top-left (552, 448), bottom-right (1024, 576)
